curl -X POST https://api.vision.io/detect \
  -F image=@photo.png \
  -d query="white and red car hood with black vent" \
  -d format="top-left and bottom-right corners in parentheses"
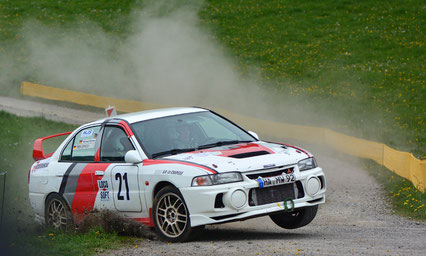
top-left (165, 141), bottom-right (312, 172)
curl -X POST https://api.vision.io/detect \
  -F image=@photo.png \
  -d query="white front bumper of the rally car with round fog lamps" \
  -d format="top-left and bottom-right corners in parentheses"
top-left (180, 167), bottom-right (326, 227)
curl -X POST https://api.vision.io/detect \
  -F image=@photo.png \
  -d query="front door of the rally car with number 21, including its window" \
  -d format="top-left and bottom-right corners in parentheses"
top-left (100, 125), bottom-right (142, 212)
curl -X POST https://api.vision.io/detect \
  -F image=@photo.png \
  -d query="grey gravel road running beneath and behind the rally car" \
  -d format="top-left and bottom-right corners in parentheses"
top-left (0, 97), bottom-right (426, 256)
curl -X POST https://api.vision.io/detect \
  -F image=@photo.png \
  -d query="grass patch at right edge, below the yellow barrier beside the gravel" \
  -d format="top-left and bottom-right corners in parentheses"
top-left (364, 160), bottom-right (426, 221)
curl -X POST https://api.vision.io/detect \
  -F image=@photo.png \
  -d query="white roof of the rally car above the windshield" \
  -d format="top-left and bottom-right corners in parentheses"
top-left (94, 107), bottom-right (209, 123)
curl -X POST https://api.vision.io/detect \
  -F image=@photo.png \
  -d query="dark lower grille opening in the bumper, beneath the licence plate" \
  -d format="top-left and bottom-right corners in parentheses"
top-left (249, 181), bottom-right (305, 206)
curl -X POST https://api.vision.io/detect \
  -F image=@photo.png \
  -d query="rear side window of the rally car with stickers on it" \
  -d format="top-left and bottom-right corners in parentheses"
top-left (61, 126), bottom-right (100, 162)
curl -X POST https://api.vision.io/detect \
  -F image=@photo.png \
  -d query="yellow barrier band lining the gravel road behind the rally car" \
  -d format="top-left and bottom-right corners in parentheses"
top-left (21, 82), bottom-right (426, 191)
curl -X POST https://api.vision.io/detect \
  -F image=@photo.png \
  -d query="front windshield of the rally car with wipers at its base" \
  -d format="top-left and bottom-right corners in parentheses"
top-left (132, 111), bottom-right (255, 158)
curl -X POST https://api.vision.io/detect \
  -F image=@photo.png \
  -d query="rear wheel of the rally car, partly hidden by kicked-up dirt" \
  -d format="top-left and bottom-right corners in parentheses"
top-left (44, 194), bottom-right (74, 230)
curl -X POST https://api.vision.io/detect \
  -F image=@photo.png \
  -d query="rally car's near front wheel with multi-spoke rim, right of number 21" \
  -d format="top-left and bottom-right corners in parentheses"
top-left (152, 186), bottom-right (196, 242)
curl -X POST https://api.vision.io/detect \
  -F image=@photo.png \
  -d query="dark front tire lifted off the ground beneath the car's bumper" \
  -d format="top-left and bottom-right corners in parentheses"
top-left (269, 205), bottom-right (318, 229)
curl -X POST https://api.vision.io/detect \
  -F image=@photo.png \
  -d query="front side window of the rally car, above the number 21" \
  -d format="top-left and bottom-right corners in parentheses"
top-left (101, 126), bottom-right (135, 162)
